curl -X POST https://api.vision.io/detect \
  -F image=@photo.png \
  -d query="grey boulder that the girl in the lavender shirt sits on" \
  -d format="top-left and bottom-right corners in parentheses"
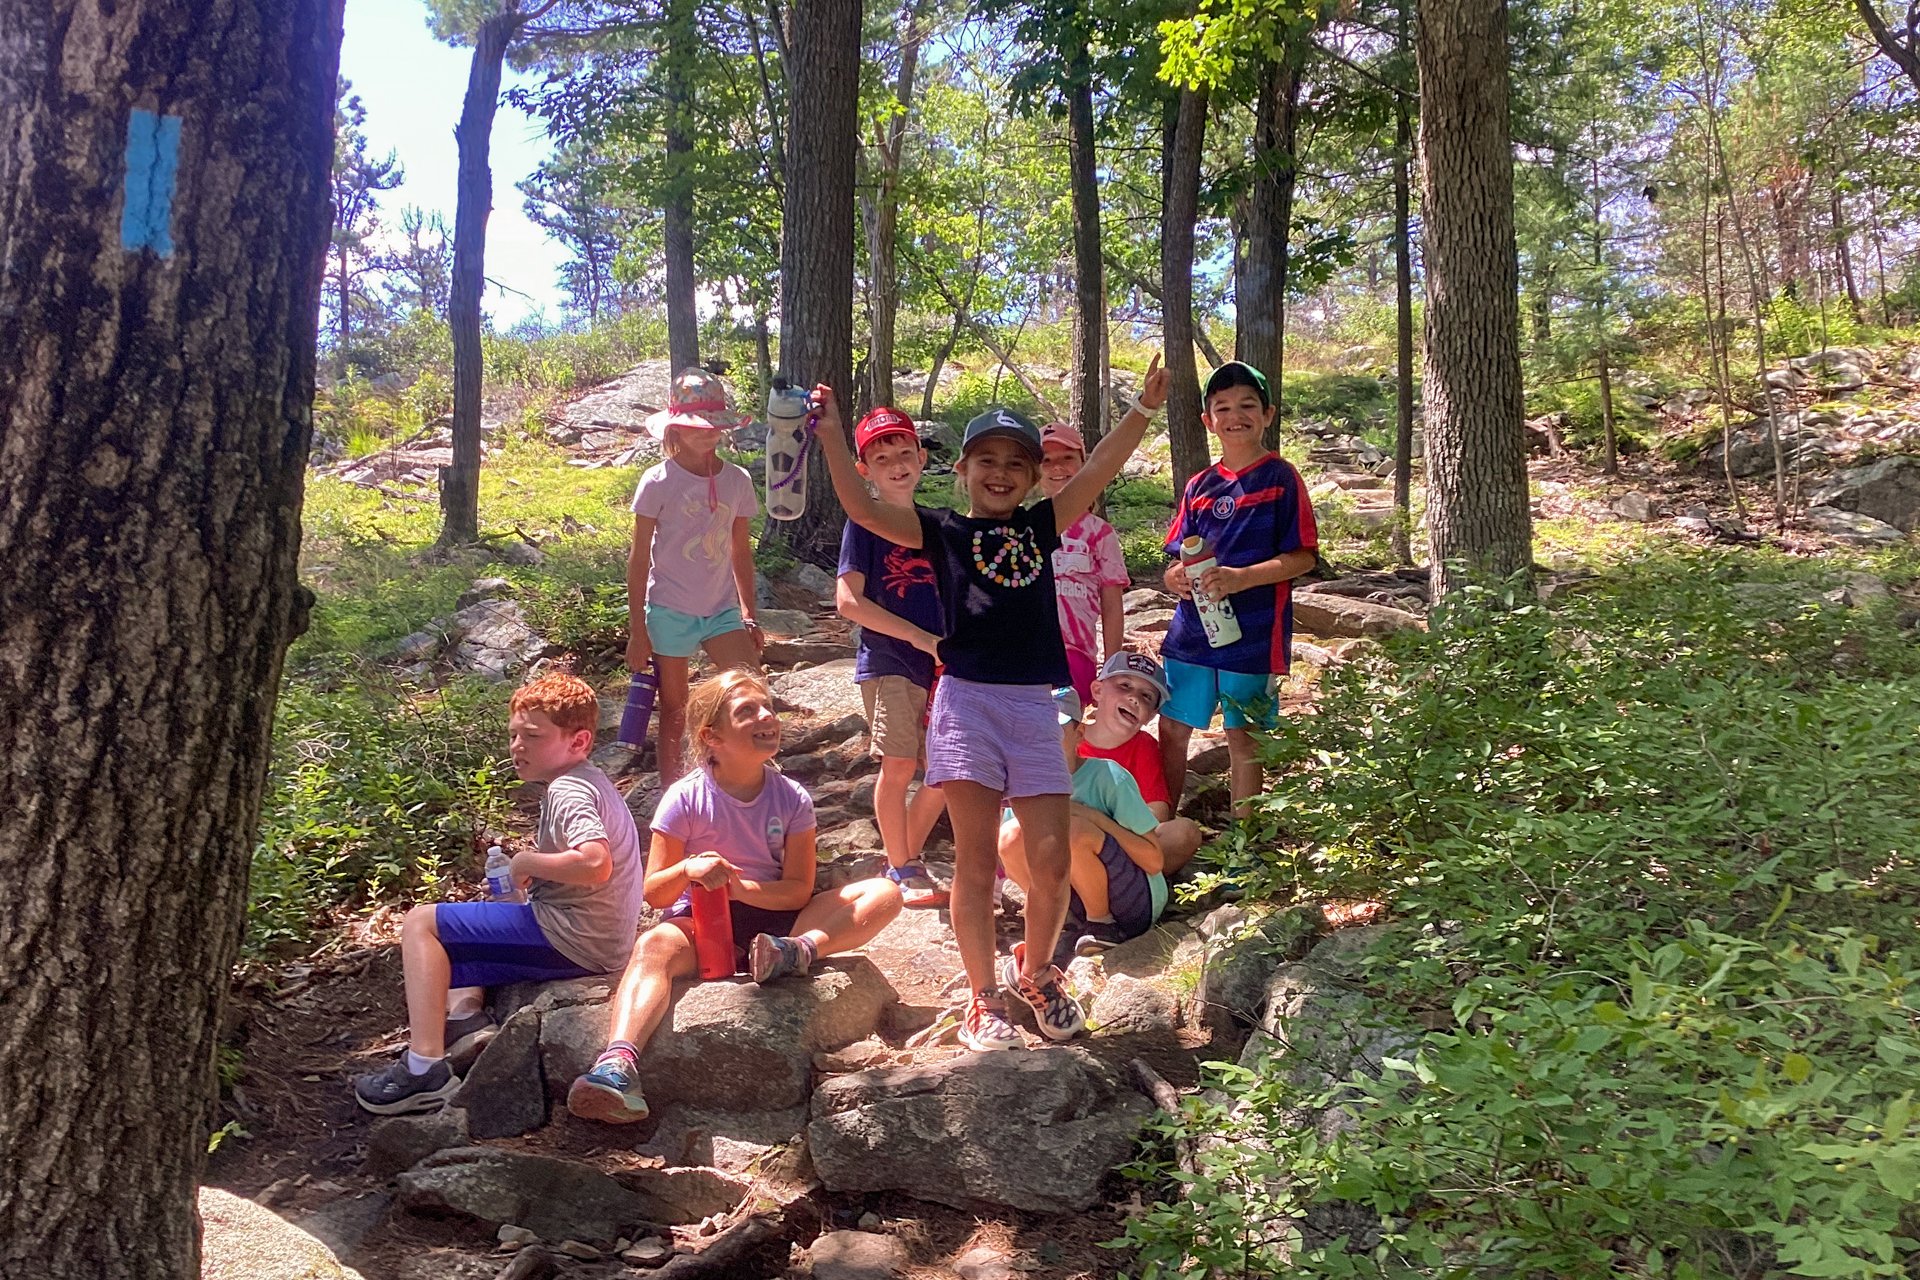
top-left (540, 956), bottom-right (899, 1111)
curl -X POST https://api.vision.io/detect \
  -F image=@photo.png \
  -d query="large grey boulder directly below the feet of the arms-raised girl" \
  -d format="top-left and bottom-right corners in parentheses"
top-left (806, 1048), bottom-right (1150, 1213)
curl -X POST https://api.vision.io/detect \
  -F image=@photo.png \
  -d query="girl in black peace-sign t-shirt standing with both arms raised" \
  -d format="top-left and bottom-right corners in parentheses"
top-left (814, 357), bottom-right (1167, 1050)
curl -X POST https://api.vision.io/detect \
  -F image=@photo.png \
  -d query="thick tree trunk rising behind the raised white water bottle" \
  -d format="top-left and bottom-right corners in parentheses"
top-left (770, 0), bottom-right (860, 568)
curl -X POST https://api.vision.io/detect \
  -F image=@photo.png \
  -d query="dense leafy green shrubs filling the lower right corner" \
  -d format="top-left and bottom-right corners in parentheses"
top-left (1129, 558), bottom-right (1920, 1278)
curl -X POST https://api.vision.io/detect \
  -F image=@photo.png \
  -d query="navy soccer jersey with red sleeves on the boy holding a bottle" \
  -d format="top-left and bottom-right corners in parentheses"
top-left (1160, 453), bottom-right (1319, 676)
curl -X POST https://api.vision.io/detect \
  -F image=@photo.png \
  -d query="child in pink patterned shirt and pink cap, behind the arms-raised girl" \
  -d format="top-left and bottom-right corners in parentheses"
top-left (1041, 422), bottom-right (1131, 702)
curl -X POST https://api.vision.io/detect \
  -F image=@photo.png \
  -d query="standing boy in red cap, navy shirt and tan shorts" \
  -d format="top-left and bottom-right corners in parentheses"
top-left (833, 409), bottom-right (947, 908)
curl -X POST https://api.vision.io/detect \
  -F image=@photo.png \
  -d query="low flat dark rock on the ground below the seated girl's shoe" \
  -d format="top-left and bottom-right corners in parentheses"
top-left (396, 1148), bottom-right (678, 1242)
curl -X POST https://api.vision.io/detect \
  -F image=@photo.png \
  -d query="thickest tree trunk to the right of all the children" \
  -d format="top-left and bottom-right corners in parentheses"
top-left (1415, 0), bottom-right (1532, 595)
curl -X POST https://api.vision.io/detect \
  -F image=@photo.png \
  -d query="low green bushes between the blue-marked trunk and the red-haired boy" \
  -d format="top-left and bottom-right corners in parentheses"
top-left (246, 675), bottom-right (513, 952)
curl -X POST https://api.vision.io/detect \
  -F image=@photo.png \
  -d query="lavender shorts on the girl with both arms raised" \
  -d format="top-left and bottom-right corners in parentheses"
top-left (927, 676), bottom-right (1073, 800)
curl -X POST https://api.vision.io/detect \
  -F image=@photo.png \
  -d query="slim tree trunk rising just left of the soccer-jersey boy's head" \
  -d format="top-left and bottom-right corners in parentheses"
top-left (1160, 88), bottom-right (1208, 493)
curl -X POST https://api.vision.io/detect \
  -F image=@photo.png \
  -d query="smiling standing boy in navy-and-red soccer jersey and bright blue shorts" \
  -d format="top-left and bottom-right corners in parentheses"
top-left (1160, 361), bottom-right (1319, 818)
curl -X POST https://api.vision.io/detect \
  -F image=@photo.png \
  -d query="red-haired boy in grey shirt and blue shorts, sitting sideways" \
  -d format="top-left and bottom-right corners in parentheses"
top-left (353, 674), bottom-right (641, 1115)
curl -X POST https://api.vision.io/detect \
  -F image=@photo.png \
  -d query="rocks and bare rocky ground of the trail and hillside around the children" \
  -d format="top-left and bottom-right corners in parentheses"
top-left (220, 351), bottom-right (1920, 1280)
